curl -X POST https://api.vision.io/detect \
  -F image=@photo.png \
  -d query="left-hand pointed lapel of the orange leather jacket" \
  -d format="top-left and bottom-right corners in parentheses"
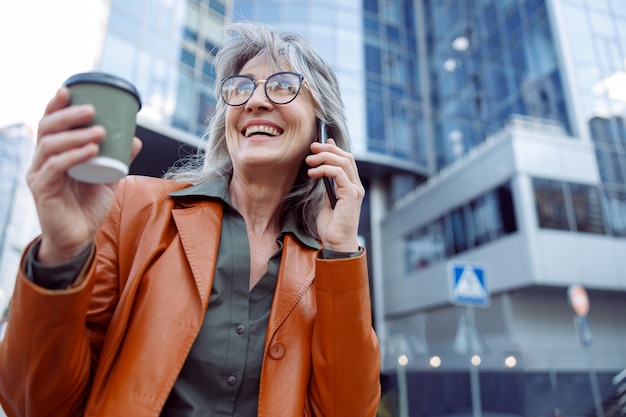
top-left (172, 202), bottom-right (223, 311)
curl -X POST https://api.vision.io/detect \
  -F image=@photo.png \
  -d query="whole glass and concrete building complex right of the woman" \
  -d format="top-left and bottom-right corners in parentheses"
top-left (233, 0), bottom-right (626, 416)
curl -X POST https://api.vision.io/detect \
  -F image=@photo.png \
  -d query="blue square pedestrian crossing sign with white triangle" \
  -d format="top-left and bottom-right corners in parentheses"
top-left (448, 262), bottom-right (491, 307)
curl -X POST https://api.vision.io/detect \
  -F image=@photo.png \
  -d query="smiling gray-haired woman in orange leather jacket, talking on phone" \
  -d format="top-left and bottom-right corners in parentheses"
top-left (0, 23), bottom-right (380, 417)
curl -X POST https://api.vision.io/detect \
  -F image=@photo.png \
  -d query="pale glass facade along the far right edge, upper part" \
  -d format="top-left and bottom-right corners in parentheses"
top-left (561, 0), bottom-right (626, 237)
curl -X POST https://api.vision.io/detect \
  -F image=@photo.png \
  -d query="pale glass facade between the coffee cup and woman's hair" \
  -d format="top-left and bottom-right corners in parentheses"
top-left (100, 0), bottom-right (228, 135)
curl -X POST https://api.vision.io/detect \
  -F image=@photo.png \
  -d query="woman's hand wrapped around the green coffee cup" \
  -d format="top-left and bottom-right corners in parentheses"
top-left (26, 87), bottom-right (141, 265)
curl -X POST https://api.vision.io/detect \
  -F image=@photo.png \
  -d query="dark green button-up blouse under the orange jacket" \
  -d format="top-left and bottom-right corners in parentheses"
top-left (161, 180), bottom-right (320, 417)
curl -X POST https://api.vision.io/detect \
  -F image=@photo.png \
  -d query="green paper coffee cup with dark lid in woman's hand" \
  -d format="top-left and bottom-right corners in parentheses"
top-left (63, 72), bottom-right (141, 184)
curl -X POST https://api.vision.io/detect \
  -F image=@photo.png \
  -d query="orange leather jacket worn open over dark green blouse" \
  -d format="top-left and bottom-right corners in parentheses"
top-left (0, 177), bottom-right (380, 417)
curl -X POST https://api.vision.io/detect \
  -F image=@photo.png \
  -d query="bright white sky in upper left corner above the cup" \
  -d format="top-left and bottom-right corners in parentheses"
top-left (0, 0), bottom-right (102, 131)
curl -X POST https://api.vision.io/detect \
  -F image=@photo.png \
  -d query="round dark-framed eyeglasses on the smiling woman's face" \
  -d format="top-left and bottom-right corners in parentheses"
top-left (222, 72), bottom-right (304, 106)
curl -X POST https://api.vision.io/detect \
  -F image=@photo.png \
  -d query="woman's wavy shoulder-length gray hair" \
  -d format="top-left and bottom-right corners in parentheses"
top-left (164, 22), bottom-right (350, 237)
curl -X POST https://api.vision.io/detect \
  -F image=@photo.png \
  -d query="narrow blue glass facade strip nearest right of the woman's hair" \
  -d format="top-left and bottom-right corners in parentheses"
top-left (363, 0), bottom-right (428, 166)
